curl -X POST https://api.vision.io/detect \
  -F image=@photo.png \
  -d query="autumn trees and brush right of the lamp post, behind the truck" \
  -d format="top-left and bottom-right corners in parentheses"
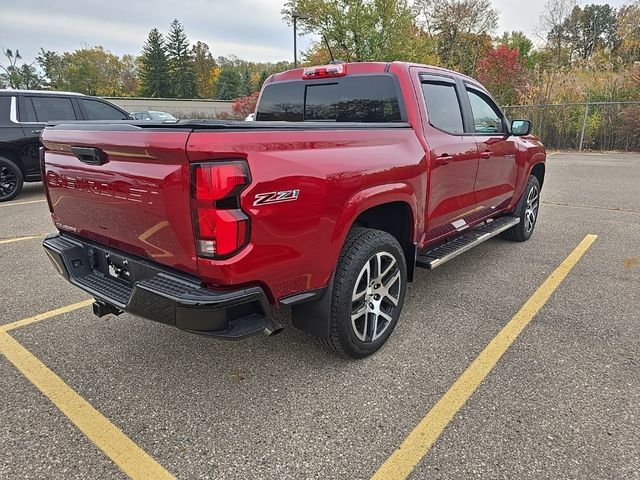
top-left (282, 0), bottom-right (640, 104)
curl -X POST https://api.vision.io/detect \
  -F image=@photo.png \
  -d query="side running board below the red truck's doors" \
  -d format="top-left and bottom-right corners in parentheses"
top-left (416, 216), bottom-right (520, 270)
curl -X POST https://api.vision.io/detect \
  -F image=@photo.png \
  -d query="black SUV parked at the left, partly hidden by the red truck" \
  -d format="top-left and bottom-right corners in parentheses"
top-left (0, 90), bottom-right (131, 202)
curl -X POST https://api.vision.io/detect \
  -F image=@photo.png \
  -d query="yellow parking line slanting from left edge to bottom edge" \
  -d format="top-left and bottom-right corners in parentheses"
top-left (0, 330), bottom-right (174, 480)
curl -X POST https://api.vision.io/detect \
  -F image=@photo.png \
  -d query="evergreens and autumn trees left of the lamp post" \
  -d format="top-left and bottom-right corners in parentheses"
top-left (0, 20), bottom-right (292, 100)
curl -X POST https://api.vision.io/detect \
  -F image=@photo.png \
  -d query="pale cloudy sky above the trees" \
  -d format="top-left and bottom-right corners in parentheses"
top-left (0, 0), bottom-right (626, 62)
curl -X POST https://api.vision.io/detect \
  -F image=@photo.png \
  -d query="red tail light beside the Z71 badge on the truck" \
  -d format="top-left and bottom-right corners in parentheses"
top-left (191, 161), bottom-right (250, 259)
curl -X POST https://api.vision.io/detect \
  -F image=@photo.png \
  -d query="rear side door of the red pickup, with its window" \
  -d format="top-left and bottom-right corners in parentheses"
top-left (419, 73), bottom-right (478, 241)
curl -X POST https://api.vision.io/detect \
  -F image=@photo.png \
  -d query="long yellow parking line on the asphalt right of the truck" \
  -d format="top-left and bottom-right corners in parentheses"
top-left (372, 235), bottom-right (598, 480)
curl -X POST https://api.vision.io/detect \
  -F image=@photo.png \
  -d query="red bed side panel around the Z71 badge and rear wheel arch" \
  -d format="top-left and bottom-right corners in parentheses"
top-left (187, 128), bottom-right (426, 301)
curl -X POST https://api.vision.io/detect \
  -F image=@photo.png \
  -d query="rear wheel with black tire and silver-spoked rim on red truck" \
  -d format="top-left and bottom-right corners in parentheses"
top-left (318, 227), bottom-right (407, 358)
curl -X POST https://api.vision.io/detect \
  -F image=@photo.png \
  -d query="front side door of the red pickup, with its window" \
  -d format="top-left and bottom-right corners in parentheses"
top-left (466, 85), bottom-right (518, 212)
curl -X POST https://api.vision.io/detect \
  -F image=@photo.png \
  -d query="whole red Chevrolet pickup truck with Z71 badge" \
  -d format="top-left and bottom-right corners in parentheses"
top-left (41, 62), bottom-right (546, 358)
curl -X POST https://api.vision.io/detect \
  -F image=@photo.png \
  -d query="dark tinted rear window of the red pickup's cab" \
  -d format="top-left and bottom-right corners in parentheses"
top-left (256, 75), bottom-right (402, 123)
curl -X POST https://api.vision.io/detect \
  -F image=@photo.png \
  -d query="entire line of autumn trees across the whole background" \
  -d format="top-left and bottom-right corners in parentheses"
top-left (0, 0), bottom-right (640, 105)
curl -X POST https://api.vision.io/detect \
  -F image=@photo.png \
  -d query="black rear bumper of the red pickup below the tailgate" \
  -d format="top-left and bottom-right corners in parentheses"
top-left (43, 234), bottom-right (282, 340)
